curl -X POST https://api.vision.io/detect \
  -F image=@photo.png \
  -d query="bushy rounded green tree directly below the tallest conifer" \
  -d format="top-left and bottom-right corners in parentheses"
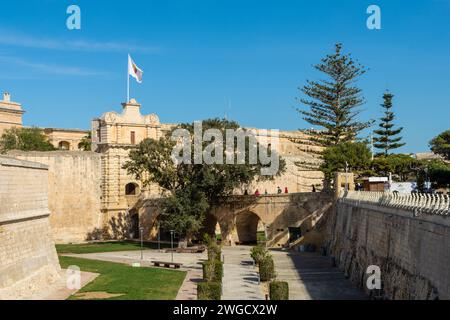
top-left (320, 142), bottom-right (372, 179)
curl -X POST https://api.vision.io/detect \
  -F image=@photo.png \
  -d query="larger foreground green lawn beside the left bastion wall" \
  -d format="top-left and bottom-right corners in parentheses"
top-left (59, 256), bottom-right (186, 300)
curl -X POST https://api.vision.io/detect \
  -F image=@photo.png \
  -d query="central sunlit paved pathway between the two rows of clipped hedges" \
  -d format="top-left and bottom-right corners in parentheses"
top-left (222, 246), bottom-right (264, 300)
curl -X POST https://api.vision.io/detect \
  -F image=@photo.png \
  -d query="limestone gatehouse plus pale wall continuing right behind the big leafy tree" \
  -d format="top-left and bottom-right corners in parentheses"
top-left (91, 99), bottom-right (323, 237)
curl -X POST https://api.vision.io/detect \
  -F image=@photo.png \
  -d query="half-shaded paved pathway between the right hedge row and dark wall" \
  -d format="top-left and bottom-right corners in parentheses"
top-left (271, 251), bottom-right (367, 300)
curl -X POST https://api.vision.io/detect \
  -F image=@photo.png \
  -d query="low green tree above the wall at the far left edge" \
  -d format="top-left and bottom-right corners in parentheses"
top-left (0, 127), bottom-right (55, 153)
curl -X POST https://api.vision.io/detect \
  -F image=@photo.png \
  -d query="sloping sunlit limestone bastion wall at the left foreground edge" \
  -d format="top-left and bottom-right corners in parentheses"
top-left (0, 156), bottom-right (60, 299)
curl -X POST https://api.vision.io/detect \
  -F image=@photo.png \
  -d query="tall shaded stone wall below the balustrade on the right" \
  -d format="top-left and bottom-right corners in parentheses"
top-left (328, 195), bottom-right (450, 299)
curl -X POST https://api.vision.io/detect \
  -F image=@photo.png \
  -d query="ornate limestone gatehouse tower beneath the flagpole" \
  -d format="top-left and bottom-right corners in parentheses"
top-left (92, 99), bottom-right (162, 236)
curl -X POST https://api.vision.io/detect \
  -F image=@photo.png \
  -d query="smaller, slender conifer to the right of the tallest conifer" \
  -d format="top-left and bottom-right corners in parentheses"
top-left (373, 92), bottom-right (405, 156)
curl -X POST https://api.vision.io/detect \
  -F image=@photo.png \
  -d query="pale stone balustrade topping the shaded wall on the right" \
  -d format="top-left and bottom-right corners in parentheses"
top-left (339, 191), bottom-right (450, 216)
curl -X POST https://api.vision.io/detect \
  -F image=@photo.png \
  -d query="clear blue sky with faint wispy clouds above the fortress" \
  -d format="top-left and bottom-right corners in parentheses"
top-left (0, 0), bottom-right (450, 152)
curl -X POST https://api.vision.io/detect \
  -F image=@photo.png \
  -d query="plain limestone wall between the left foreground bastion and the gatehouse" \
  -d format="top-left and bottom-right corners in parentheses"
top-left (9, 151), bottom-right (102, 243)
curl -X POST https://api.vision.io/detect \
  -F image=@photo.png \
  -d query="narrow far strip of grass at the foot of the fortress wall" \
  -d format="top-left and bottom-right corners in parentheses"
top-left (56, 241), bottom-right (172, 253)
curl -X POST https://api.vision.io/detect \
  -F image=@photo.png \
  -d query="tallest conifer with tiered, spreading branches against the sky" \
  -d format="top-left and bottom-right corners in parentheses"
top-left (297, 43), bottom-right (372, 147)
